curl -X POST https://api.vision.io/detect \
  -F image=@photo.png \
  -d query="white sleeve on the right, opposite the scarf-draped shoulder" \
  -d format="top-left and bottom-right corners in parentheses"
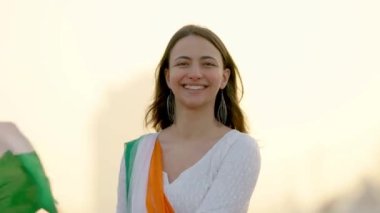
top-left (196, 134), bottom-right (261, 213)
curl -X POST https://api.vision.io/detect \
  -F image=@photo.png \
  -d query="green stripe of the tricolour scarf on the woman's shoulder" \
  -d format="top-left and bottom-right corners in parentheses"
top-left (124, 137), bottom-right (141, 212)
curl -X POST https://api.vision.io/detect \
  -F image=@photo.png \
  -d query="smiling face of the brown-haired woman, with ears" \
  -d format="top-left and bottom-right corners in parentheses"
top-left (165, 35), bottom-right (230, 109)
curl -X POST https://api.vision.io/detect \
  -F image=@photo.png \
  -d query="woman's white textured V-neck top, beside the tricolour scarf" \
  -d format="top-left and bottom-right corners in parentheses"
top-left (117, 130), bottom-right (260, 213)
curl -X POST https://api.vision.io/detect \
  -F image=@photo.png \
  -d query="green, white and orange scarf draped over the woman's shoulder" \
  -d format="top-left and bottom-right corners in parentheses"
top-left (124, 134), bottom-right (174, 213)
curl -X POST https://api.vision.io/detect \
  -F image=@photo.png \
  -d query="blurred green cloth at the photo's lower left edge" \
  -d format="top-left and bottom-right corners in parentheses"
top-left (0, 151), bottom-right (57, 213)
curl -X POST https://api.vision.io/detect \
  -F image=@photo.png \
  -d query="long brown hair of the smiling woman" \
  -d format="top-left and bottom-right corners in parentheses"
top-left (145, 25), bottom-right (247, 132)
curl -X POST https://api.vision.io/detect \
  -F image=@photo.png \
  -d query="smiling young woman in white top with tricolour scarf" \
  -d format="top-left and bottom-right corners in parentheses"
top-left (117, 25), bottom-right (260, 213)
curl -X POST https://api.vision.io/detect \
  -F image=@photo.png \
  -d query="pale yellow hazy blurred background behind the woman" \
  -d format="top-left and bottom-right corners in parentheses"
top-left (0, 0), bottom-right (380, 213)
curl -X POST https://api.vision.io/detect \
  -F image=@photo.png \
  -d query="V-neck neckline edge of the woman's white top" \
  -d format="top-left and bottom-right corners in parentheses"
top-left (162, 129), bottom-right (236, 187)
